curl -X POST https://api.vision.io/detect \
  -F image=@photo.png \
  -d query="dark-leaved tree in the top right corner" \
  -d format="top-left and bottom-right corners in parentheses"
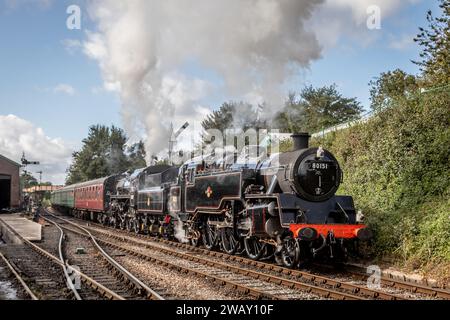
top-left (414, 0), bottom-right (450, 85)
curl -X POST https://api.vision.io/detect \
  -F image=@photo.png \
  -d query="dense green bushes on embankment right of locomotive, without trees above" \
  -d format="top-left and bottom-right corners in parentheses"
top-left (312, 92), bottom-right (450, 264)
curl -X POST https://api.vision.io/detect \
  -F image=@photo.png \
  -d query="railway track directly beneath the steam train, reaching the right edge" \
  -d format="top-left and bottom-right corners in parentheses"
top-left (46, 209), bottom-right (450, 300)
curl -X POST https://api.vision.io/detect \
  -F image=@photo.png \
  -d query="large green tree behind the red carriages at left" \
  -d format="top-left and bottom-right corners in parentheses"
top-left (66, 125), bottom-right (133, 184)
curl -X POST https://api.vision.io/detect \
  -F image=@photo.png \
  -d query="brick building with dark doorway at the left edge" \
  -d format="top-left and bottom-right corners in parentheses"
top-left (0, 154), bottom-right (20, 211)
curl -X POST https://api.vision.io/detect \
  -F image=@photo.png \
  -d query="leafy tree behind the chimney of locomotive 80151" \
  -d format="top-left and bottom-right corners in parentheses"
top-left (274, 85), bottom-right (362, 133)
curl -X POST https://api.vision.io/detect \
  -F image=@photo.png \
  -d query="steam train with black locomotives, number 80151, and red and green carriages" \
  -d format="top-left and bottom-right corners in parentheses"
top-left (53, 134), bottom-right (370, 267)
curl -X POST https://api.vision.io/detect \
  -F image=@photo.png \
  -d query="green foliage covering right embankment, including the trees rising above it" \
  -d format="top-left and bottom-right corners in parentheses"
top-left (313, 0), bottom-right (450, 268)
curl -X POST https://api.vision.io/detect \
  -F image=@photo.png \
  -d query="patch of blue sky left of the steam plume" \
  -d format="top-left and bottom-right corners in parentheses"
top-left (0, 1), bottom-right (120, 144)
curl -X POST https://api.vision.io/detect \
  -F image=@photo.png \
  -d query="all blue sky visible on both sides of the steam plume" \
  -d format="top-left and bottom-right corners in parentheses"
top-left (0, 0), bottom-right (438, 182)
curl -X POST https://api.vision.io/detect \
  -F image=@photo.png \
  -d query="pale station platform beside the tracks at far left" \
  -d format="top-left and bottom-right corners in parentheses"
top-left (0, 214), bottom-right (42, 241)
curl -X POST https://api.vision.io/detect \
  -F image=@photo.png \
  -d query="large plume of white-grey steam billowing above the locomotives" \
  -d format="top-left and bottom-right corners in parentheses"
top-left (84, 0), bottom-right (323, 158)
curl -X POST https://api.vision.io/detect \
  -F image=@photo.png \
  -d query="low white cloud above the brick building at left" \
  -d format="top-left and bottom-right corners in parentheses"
top-left (0, 115), bottom-right (73, 184)
